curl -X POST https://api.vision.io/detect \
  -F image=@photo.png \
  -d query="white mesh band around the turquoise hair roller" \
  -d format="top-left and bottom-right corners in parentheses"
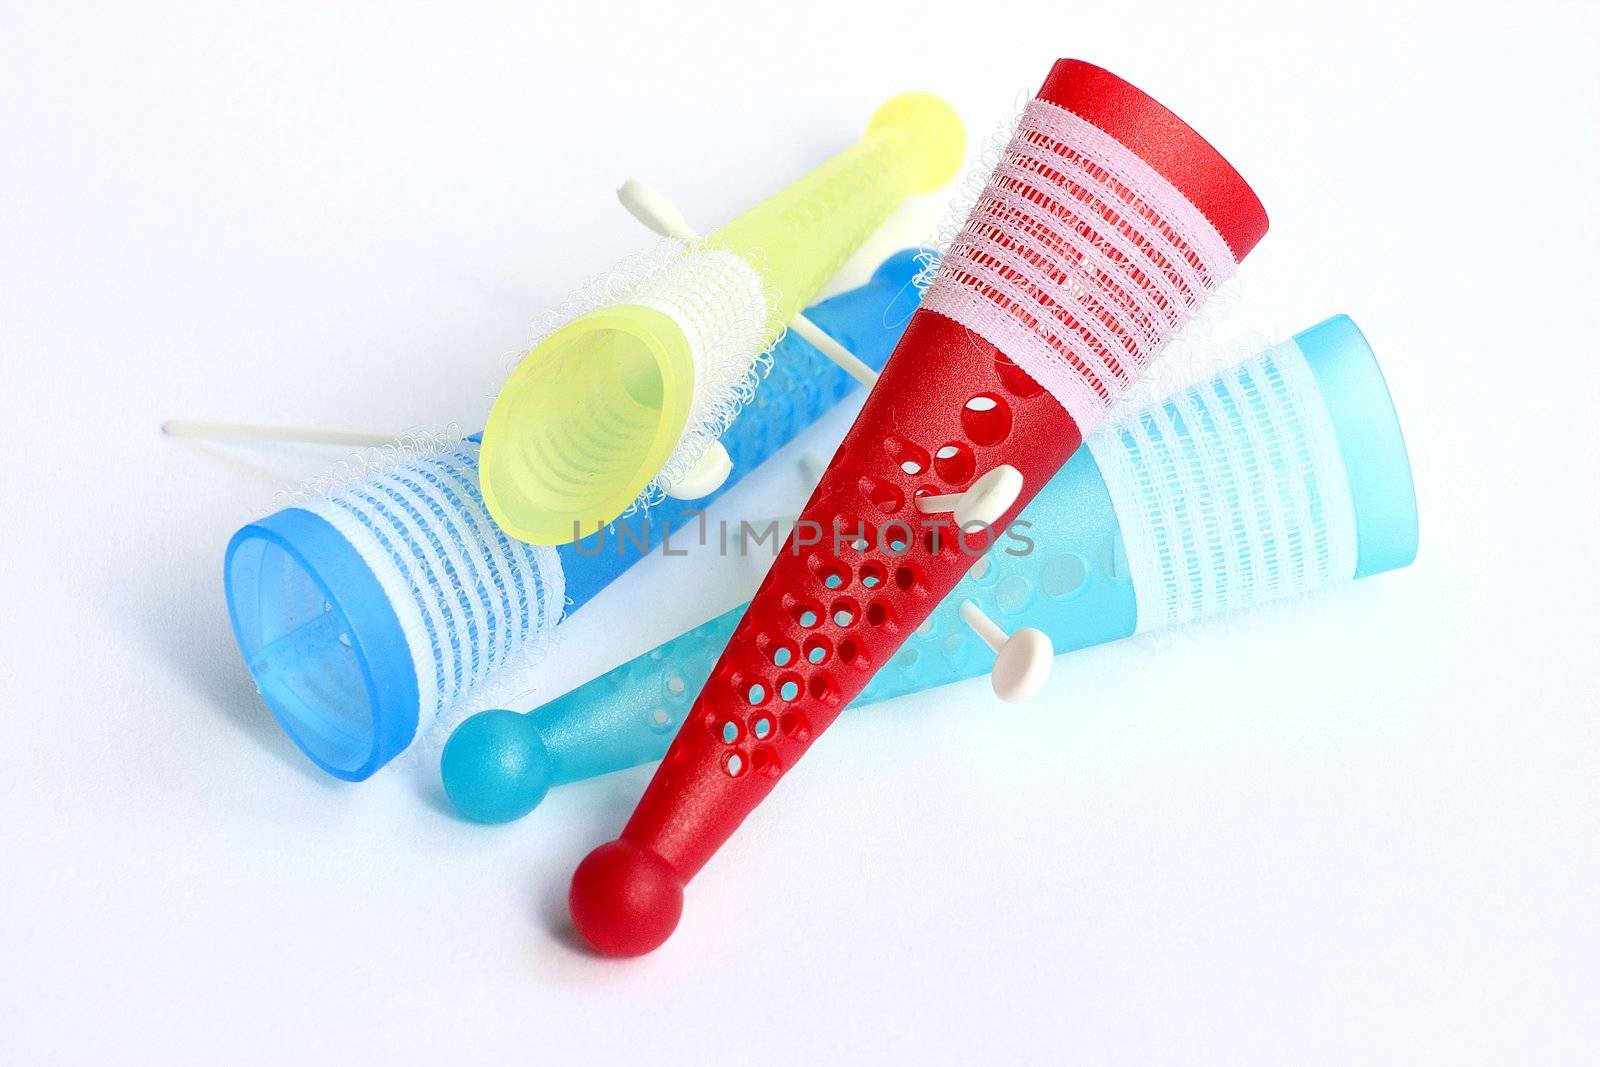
top-left (1086, 341), bottom-right (1357, 630)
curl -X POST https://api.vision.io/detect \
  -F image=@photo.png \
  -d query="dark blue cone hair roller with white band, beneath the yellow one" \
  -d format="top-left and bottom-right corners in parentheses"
top-left (224, 250), bottom-right (918, 781)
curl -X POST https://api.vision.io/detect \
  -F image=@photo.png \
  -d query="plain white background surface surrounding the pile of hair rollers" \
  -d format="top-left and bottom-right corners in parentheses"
top-left (0, 0), bottom-right (1600, 1064)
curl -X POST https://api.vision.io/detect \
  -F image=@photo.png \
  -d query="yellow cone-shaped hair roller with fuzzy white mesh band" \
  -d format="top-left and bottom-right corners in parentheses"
top-left (467, 93), bottom-right (965, 544)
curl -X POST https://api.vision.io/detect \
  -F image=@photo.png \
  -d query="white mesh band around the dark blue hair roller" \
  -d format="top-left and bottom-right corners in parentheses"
top-left (296, 442), bottom-right (565, 734)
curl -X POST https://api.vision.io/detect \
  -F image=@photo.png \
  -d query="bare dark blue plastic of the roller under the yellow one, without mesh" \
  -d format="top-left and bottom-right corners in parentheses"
top-left (222, 250), bottom-right (918, 781)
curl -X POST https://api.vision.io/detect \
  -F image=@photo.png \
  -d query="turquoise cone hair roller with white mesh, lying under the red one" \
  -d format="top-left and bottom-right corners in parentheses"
top-left (440, 315), bottom-right (1418, 822)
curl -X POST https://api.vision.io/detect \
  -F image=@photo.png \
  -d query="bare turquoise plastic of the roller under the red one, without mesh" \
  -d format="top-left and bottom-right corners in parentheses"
top-left (440, 317), bottom-right (1416, 822)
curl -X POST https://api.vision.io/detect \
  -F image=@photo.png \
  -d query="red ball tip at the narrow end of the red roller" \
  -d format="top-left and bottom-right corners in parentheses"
top-left (566, 841), bottom-right (683, 957)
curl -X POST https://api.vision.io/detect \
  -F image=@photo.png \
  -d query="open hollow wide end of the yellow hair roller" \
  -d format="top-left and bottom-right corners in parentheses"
top-left (480, 304), bottom-right (694, 544)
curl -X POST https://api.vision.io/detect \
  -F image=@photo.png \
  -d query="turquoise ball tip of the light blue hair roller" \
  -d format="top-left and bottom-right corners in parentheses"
top-left (438, 710), bottom-right (552, 822)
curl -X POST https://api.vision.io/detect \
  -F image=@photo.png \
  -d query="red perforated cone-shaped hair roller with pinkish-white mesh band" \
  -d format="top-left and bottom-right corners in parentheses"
top-left (570, 61), bottom-right (1267, 955)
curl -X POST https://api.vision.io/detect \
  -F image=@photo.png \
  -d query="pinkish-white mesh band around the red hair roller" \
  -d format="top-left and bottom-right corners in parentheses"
top-left (922, 99), bottom-right (1237, 435)
